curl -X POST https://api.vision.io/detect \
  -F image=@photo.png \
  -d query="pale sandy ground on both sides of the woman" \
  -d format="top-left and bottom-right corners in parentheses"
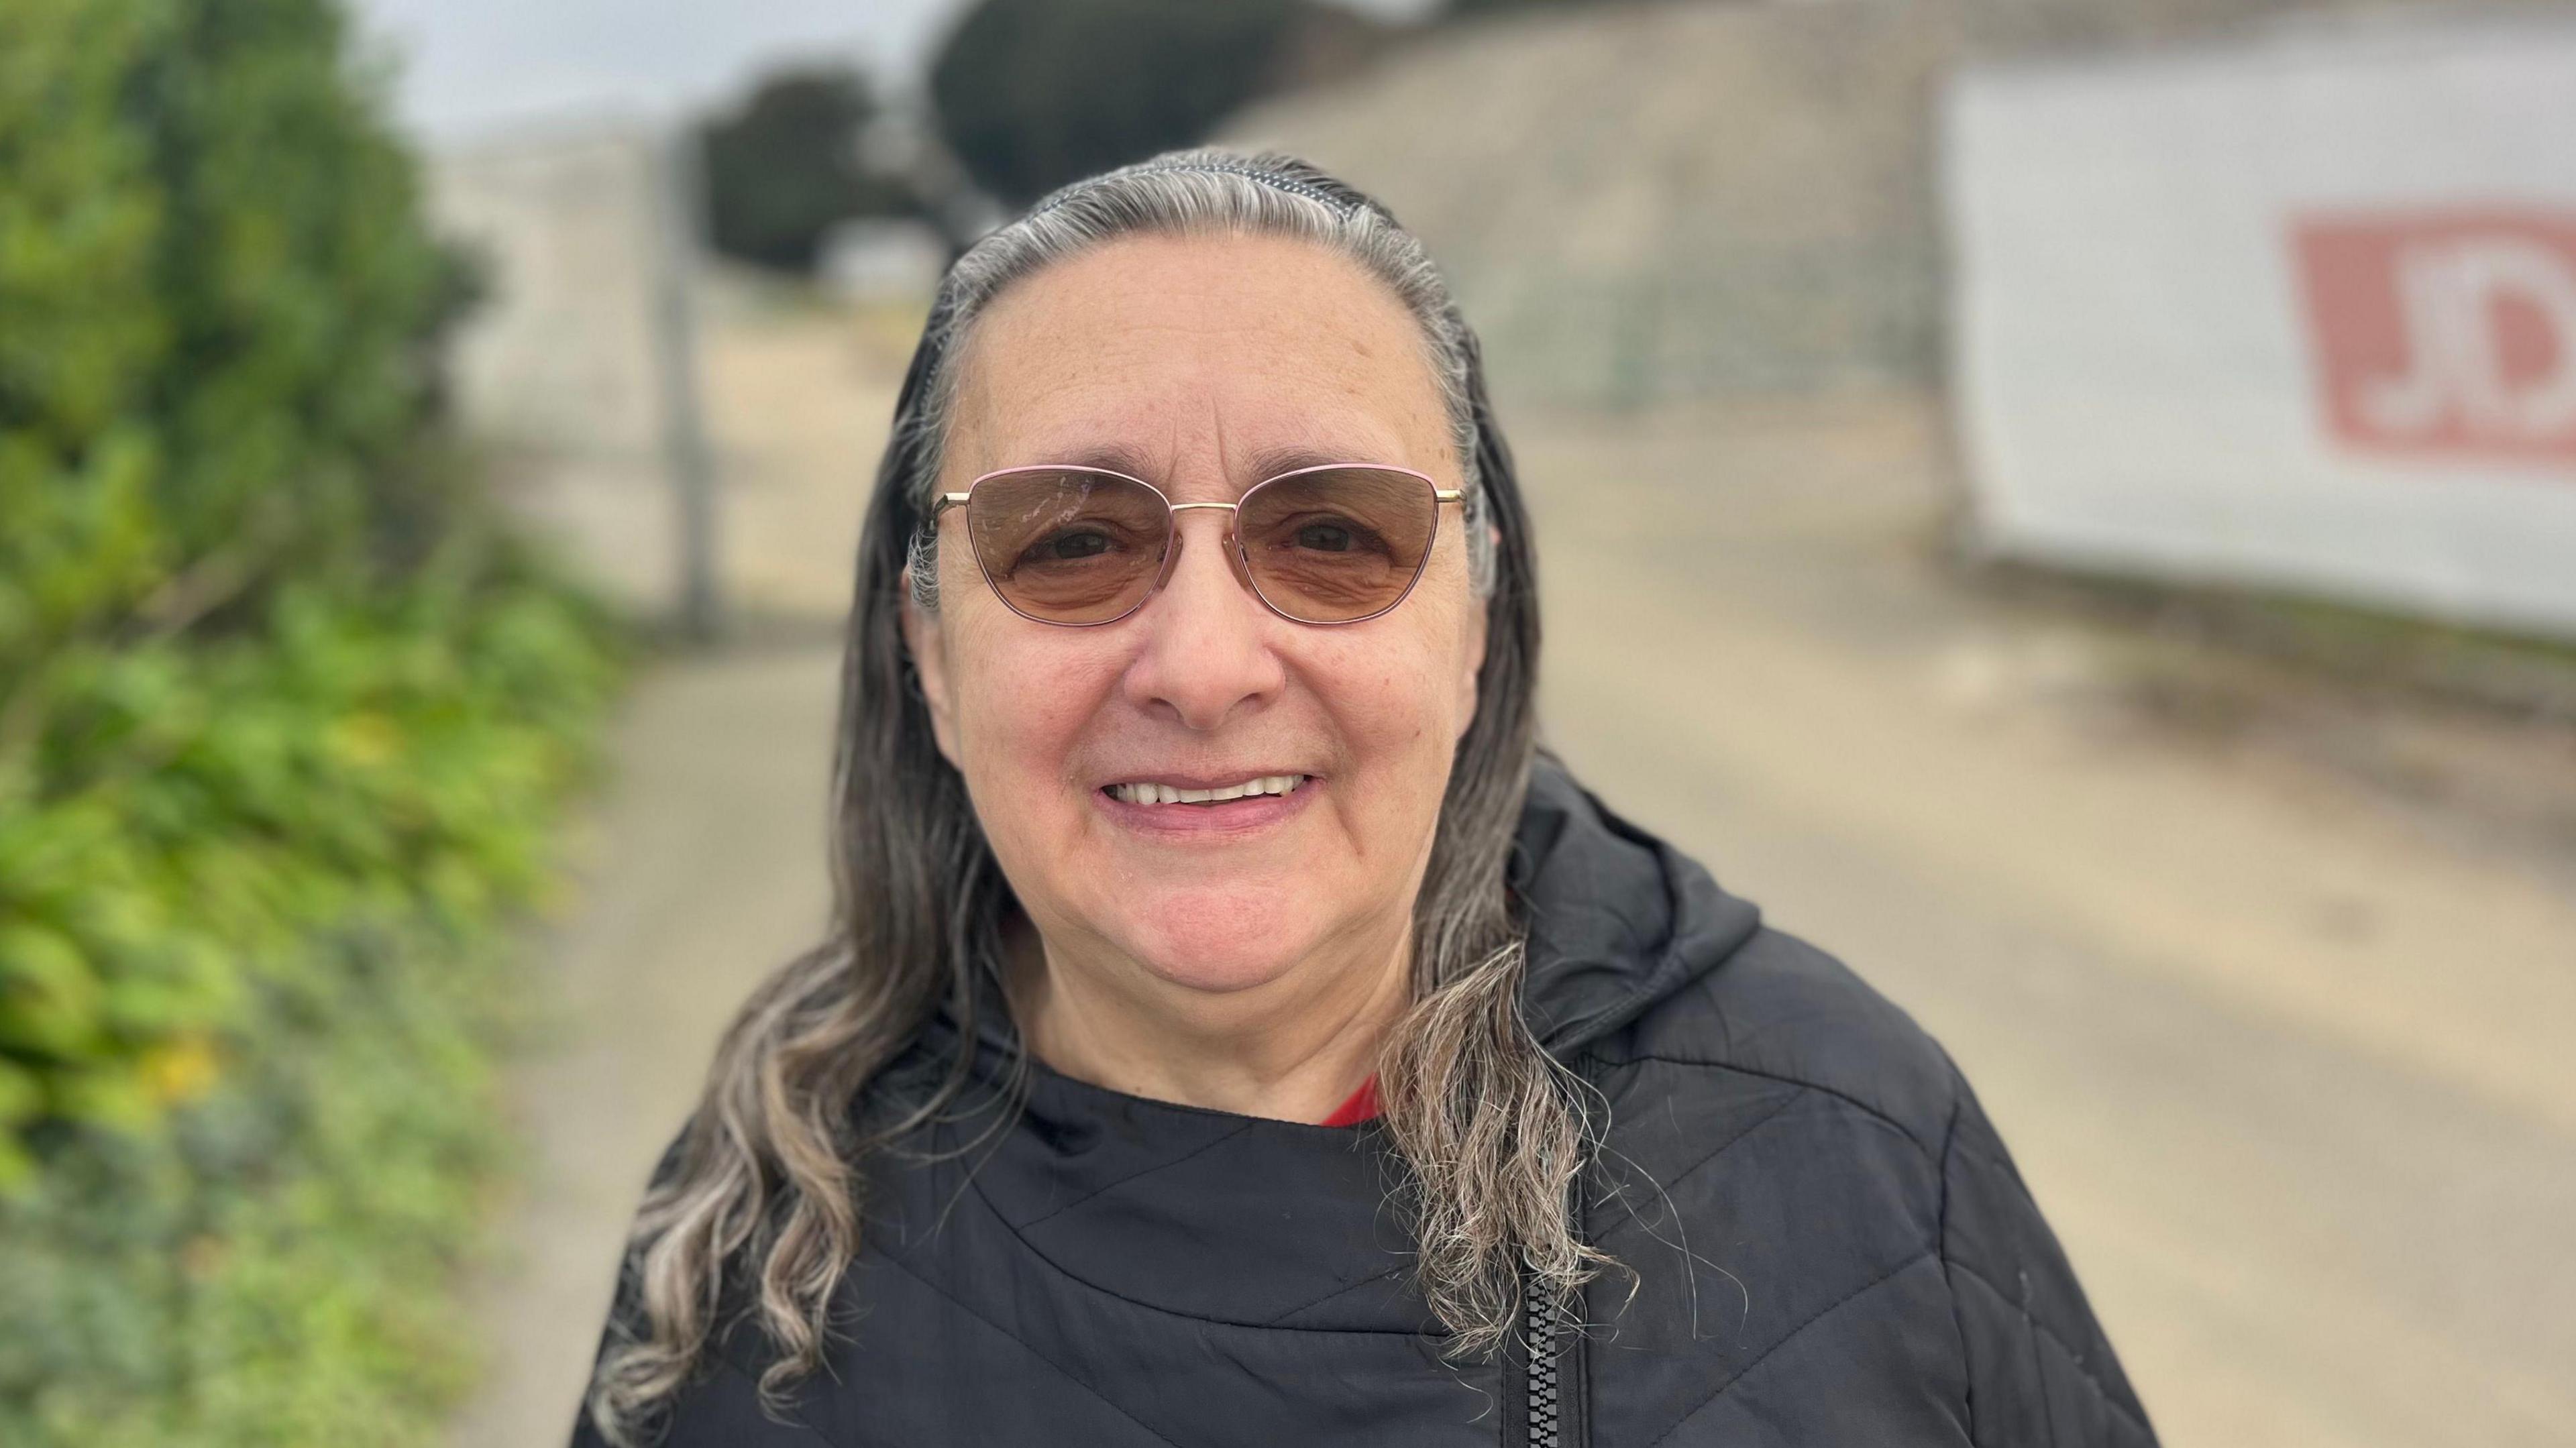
top-left (456, 298), bottom-right (2576, 1448)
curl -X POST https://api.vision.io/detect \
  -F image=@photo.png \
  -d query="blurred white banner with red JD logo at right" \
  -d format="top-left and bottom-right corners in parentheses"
top-left (1945, 21), bottom-right (2576, 634)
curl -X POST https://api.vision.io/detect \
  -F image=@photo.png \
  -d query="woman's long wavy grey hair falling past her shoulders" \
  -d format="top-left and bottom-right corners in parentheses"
top-left (590, 150), bottom-right (1607, 1443)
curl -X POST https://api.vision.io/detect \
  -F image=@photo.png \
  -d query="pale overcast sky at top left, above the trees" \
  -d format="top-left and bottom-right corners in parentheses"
top-left (355, 0), bottom-right (1438, 142)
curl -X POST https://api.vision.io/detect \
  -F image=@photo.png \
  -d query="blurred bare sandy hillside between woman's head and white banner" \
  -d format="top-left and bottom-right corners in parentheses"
top-left (1224, 0), bottom-right (1953, 407)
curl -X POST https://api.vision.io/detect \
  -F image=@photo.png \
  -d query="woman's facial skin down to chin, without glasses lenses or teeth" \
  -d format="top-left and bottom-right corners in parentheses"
top-left (904, 237), bottom-right (1484, 992)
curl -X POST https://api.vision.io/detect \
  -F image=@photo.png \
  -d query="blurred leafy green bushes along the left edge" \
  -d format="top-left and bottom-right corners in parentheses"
top-left (0, 0), bottom-right (619, 1445)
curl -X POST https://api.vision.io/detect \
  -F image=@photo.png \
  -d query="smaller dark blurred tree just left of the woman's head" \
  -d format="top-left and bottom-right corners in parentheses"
top-left (703, 67), bottom-right (917, 270)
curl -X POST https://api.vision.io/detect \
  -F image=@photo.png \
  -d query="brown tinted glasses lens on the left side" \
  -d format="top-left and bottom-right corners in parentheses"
top-left (966, 469), bottom-right (1172, 624)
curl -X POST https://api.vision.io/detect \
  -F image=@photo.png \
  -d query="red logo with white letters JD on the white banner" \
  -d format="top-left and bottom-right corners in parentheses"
top-left (2293, 211), bottom-right (2576, 461)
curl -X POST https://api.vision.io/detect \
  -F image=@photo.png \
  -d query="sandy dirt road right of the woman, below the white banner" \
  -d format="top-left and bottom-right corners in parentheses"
top-left (1522, 402), bottom-right (2576, 1448)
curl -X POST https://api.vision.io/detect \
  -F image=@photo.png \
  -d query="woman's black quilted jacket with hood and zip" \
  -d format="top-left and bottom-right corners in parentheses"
top-left (574, 763), bottom-right (2153, 1448)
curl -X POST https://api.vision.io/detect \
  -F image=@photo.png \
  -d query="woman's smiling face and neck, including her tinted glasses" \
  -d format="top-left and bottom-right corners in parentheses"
top-left (904, 235), bottom-right (1487, 1103)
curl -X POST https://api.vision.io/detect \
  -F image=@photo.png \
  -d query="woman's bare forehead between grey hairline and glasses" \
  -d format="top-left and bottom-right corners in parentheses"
top-left (953, 237), bottom-right (1448, 474)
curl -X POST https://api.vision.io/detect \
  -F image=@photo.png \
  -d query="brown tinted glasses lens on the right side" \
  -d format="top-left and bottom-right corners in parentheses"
top-left (1234, 466), bottom-right (1440, 624)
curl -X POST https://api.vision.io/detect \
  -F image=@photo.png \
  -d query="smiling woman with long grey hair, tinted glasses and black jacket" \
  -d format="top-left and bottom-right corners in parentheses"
top-left (574, 150), bottom-right (2153, 1448)
